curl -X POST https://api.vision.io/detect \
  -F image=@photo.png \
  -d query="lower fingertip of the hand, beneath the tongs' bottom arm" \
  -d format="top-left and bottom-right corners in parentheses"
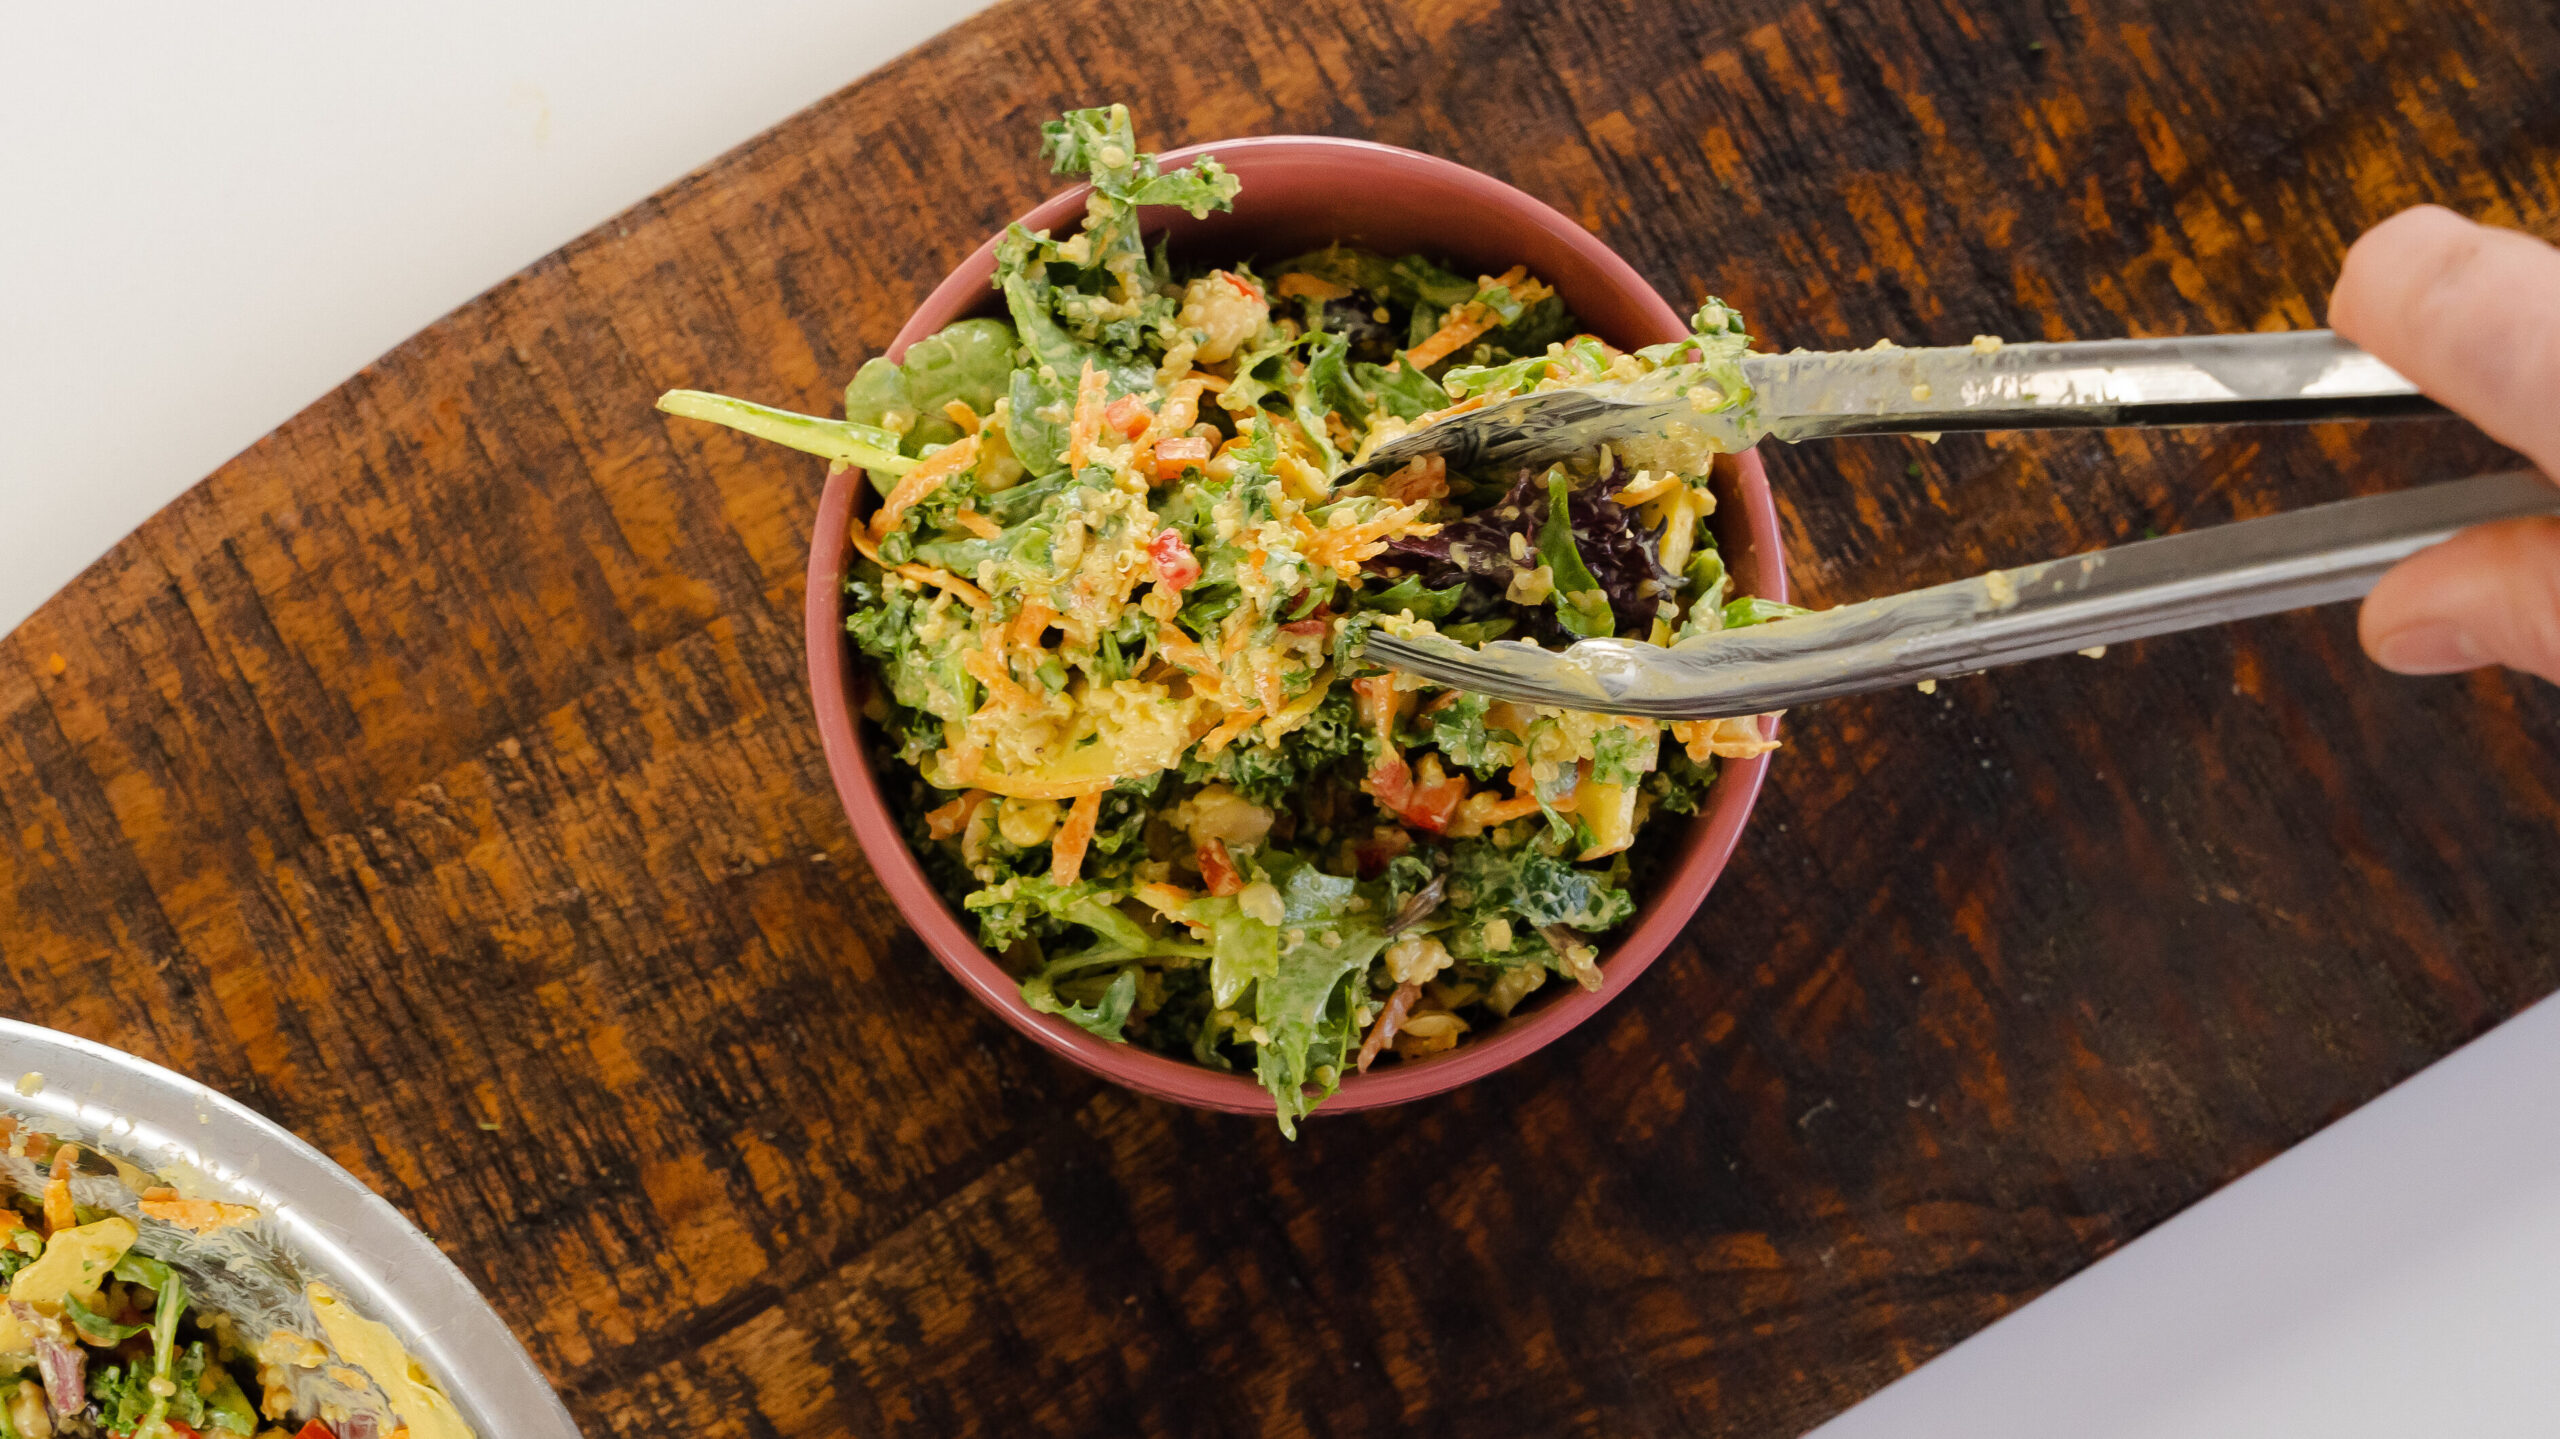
top-left (2358, 517), bottom-right (2560, 684)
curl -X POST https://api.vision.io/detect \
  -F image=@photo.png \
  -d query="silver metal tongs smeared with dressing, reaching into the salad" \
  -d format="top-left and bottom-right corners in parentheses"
top-left (1344, 330), bottom-right (2560, 720)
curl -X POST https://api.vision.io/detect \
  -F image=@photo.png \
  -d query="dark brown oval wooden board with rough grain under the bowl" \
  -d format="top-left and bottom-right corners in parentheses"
top-left (0, 0), bottom-right (2560, 1436)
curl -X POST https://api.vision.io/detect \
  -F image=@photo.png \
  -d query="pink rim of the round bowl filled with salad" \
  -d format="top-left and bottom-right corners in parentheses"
top-left (804, 136), bottom-right (1787, 1116)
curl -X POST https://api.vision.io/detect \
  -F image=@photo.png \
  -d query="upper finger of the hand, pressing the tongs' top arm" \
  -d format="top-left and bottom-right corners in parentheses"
top-left (2330, 205), bottom-right (2560, 476)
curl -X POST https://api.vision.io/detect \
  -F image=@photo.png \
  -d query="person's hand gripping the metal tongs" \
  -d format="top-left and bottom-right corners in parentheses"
top-left (2330, 205), bottom-right (2560, 681)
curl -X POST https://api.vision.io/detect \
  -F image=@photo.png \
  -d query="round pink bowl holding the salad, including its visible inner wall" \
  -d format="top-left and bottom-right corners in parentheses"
top-left (809, 136), bottom-right (1787, 1114)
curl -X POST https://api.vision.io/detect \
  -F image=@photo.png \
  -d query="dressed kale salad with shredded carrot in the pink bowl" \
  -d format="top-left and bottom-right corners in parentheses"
top-left (660, 105), bottom-right (1789, 1132)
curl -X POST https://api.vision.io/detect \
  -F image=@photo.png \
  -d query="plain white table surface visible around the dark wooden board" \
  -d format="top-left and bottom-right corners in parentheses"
top-left (0, 0), bottom-right (2560, 1439)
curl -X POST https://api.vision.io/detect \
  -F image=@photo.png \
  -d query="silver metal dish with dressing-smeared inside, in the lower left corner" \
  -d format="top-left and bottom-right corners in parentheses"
top-left (0, 1019), bottom-right (579, 1439)
